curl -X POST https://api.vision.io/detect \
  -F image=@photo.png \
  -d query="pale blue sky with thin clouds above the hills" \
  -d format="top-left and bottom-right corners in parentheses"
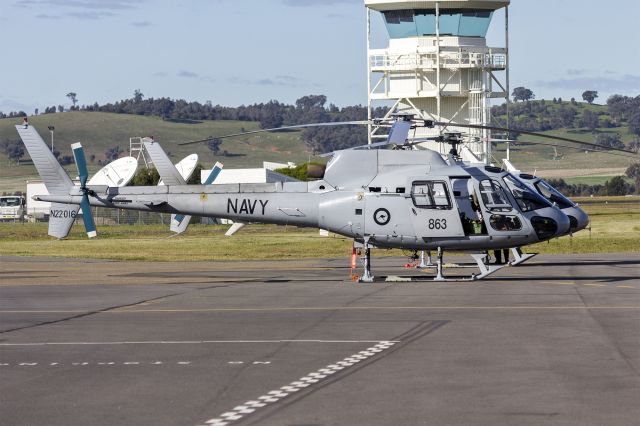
top-left (0, 0), bottom-right (640, 113)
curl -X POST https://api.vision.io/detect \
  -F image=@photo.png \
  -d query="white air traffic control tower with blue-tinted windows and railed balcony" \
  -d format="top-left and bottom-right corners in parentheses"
top-left (364, 0), bottom-right (510, 164)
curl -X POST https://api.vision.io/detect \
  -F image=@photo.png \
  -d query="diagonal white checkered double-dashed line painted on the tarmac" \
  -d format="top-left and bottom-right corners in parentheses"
top-left (199, 341), bottom-right (399, 426)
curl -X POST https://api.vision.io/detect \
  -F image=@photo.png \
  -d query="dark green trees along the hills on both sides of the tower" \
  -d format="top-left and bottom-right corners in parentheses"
top-left (0, 87), bottom-right (640, 162)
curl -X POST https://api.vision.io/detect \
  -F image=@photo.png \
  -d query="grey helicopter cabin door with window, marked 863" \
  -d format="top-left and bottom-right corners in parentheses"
top-left (408, 176), bottom-right (465, 238)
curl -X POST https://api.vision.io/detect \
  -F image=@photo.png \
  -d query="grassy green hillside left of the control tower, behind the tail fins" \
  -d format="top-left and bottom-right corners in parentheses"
top-left (0, 111), bottom-right (318, 193)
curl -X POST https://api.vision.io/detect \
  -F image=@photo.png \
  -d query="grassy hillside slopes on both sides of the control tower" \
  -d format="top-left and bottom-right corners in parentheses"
top-left (0, 101), bottom-right (640, 194)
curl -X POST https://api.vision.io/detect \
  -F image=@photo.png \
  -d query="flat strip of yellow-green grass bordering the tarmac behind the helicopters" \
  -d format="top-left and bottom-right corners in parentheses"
top-left (0, 197), bottom-right (640, 261)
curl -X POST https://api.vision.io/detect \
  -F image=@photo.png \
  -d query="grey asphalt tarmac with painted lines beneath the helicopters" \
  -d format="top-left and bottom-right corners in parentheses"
top-left (0, 254), bottom-right (640, 426)
